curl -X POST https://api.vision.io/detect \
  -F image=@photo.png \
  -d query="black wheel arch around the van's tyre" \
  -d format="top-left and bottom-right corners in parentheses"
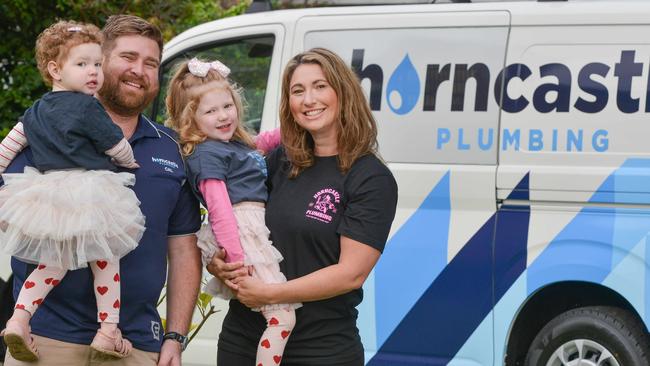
top-left (504, 281), bottom-right (647, 366)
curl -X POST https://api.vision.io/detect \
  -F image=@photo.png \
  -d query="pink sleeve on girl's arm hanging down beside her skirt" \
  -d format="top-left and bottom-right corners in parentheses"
top-left (199, 179), bottom-right (244, 263)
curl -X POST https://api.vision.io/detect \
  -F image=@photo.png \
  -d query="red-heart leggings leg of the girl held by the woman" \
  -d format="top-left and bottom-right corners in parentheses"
top-left (255, 308), bottom-right (296, 366)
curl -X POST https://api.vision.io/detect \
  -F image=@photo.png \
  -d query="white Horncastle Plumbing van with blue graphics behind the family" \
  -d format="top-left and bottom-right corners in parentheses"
top-left (153, 0), bottom-right (650, 366)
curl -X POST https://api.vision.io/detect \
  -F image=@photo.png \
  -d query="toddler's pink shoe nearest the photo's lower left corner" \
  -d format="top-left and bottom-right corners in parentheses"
top-left (0, 309), bottom-right (38, 362)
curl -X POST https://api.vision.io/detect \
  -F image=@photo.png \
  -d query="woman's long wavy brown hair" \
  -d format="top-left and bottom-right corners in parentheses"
top-left (280, 48), bottom-right (377, 178)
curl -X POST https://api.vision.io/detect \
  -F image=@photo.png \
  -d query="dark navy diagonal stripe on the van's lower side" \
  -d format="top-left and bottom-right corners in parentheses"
top-left (368, 175), bottom-right (530, 366)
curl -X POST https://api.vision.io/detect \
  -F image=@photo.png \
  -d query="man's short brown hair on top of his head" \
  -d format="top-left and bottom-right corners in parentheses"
top-left (102, 14), bottom-right (163, 58)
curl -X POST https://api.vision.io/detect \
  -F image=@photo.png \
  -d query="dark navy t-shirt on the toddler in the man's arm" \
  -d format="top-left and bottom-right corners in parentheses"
top-left (21, 91), bottom-right (124, 171)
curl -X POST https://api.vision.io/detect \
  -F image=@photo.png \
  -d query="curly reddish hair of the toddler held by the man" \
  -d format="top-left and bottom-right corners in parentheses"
top-left (35, 20), bottom-right (103, 86)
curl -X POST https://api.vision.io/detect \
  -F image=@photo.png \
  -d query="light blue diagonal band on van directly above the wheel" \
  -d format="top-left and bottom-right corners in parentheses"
top-left (527, 159), bottom-right (650, 298)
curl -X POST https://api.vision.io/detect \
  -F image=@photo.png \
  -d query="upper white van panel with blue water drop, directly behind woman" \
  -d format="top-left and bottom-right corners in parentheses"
top-left (295, 12), bottom-right (508, 165)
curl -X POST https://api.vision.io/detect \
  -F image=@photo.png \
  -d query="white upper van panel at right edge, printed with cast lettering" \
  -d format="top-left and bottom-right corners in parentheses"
top-left (497, 25), bottom-right (650, 203)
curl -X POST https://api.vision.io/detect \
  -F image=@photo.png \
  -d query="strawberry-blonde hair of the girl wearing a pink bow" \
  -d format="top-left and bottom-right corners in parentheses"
top-left (165, 62), bottom-right (255, 156)
